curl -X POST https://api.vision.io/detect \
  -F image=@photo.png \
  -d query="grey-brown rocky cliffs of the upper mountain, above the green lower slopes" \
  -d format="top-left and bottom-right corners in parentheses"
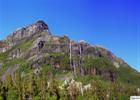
top-left (0, 20), bottom-right (140, 85)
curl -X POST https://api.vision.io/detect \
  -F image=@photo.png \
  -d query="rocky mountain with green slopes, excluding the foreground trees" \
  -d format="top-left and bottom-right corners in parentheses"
top-left (0, 20), bottom-right (140, 99)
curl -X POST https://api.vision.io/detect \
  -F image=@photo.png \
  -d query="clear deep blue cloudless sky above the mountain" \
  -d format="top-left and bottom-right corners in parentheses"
top-left (0, 0), bottom-right (140, 71)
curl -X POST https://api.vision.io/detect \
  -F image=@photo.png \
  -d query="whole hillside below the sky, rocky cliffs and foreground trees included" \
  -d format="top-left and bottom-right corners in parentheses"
top-left (0, 20), bottom-right (140, 100)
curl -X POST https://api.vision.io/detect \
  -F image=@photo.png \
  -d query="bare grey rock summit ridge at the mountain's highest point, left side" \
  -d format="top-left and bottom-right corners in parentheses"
top-left (5, 20), bottom-right (50, 47)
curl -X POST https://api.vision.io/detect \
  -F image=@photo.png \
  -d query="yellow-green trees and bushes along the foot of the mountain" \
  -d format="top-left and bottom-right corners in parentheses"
top-left (0, 68), bottom-right (140, 100)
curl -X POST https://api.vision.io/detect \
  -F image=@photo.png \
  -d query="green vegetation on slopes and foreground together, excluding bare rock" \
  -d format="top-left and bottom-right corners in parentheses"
top-left (0, 47), bottom-right (140, 100)
